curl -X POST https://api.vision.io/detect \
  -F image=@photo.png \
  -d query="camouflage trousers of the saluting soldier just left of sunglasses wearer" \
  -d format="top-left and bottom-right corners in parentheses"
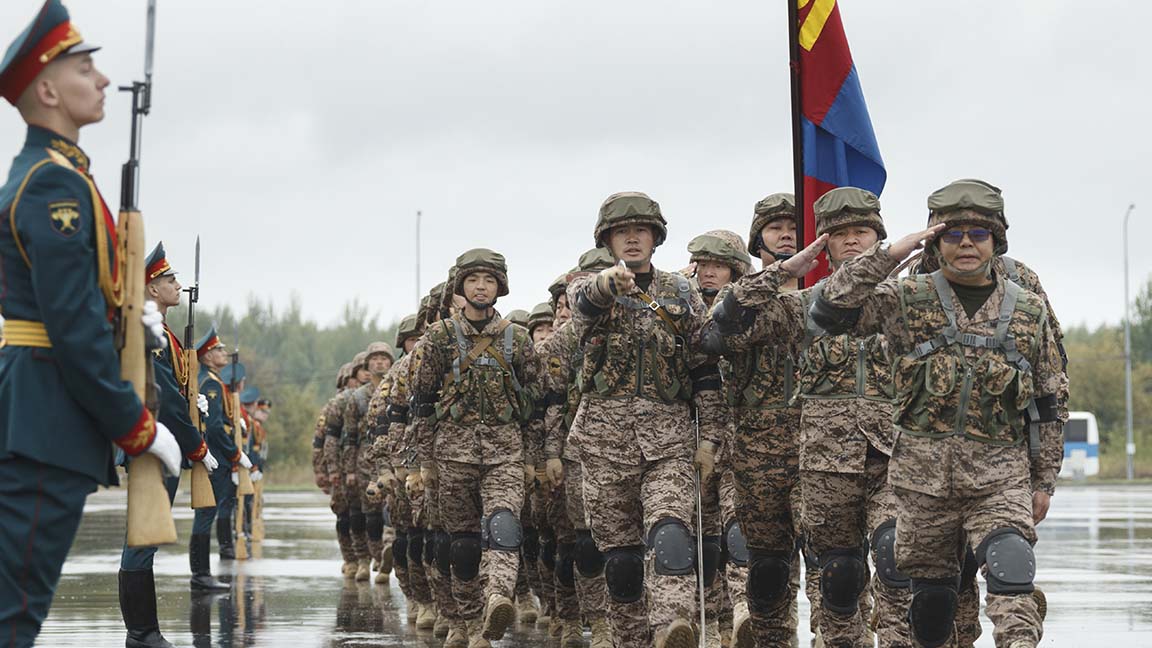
top-left (801, 446), bottom-right (911, 648)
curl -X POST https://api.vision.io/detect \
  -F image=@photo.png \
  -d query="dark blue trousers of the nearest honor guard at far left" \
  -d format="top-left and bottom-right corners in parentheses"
top-left (0, 457), bottom-right (96, 648)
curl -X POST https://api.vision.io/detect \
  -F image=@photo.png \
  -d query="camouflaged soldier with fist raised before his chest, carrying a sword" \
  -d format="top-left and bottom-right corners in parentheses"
top-left (569, 193), bottom-right (721, 648)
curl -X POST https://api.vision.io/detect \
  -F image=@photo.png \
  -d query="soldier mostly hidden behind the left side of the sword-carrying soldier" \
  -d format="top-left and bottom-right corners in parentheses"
top-left (538, 248), bottom-right (615, 648)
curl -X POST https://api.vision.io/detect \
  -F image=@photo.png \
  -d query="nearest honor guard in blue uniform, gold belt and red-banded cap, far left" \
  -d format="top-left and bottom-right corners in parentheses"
top-left (0, 0), bottom-right (181, 647)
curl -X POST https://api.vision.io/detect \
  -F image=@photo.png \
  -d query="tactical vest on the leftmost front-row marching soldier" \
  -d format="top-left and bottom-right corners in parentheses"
top-left (435, 319), bottom-right (532, 425)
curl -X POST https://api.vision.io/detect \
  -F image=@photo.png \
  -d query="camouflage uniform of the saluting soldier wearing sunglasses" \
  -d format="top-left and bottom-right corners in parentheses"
top-left (824, 238), bottom-right (1067, 646)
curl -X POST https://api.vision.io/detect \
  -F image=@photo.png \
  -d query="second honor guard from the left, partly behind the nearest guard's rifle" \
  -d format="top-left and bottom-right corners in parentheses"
top-left (119, 243), bottom-right (218, 648)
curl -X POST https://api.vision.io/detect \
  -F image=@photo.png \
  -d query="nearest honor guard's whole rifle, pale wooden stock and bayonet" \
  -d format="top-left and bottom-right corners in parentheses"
top-left (116, 0), bottom-right (176, 547)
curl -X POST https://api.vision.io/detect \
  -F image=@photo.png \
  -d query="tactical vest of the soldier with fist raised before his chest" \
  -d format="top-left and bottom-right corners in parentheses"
top-left (579, 273), bottom-right (692, 402)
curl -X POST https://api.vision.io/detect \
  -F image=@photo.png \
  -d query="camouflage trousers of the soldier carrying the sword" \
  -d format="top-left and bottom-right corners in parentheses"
top-left (582, 453), bottom-right (696, 646)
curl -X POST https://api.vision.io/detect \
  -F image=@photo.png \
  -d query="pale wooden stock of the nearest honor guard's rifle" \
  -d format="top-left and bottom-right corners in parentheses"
top-left (116, 211), bottom-right (176, 547)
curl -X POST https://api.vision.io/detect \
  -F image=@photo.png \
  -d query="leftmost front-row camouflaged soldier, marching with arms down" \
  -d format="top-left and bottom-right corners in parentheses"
top-left (412, 248), bottom-right (537, 647)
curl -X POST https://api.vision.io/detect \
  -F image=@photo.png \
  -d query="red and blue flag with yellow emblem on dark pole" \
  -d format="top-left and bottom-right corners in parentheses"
top-left (789, 0), bottom-right (887, 286)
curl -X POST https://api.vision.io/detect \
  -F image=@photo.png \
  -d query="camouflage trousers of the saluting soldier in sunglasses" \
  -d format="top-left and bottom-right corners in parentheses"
top-left (895, 475), bottom-right (1043, 646)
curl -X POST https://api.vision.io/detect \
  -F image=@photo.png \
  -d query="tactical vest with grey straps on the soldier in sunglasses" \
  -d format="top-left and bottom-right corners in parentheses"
top-left (893, 271), bottom-right (1047, 450)
